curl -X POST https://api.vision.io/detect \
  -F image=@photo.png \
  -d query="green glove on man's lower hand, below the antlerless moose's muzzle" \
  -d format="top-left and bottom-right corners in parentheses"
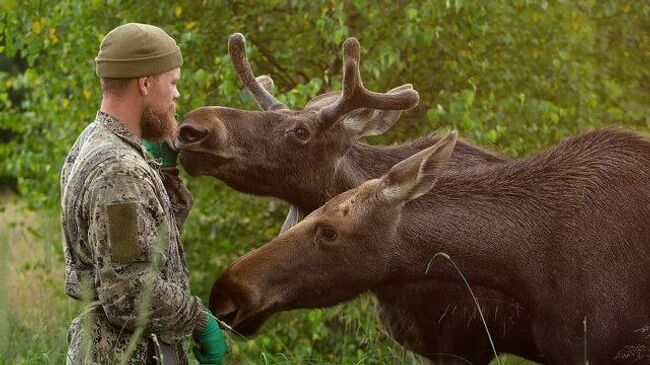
top-left (193, 313), bottom-right (228, 365)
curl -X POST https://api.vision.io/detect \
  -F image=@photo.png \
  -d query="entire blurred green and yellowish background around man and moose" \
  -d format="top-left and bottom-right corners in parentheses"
top-left (0, 0), bottom-right (650, 364)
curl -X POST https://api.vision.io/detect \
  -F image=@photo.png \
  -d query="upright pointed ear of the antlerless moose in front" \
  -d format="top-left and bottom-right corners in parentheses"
top-left (379, 131), bottom-right (458, 204)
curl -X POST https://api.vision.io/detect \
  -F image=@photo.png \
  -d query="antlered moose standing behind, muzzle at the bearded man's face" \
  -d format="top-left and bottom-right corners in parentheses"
top-left (176, 34), bottom-right (538, 364)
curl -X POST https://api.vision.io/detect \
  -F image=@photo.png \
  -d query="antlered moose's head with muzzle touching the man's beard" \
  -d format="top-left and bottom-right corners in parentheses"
top-left (175, 33), bottom-right (419, 210)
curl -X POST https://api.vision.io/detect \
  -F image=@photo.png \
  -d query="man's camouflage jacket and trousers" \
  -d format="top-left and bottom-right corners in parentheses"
top-left (61, 112), bottom-right (207, 364)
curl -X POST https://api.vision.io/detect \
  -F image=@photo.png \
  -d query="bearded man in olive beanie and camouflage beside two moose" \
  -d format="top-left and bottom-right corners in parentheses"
top-left (61, 23), bottom-right (226, 364)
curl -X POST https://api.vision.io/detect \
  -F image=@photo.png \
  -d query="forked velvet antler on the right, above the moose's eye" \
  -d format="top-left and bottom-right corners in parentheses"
top-left (319, 37), bottom-right (420, 125)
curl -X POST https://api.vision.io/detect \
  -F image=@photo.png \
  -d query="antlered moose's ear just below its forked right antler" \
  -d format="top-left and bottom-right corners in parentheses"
top-left (342, 84), bottom-right (413, 138)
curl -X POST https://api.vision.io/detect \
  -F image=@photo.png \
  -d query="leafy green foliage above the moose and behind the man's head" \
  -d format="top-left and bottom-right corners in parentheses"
top-left (0, 0), bottom-right (650, 206)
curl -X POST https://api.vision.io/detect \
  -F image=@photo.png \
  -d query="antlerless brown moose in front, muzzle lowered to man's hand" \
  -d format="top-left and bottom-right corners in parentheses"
top-left (210, 129), bottom-right (650, 364)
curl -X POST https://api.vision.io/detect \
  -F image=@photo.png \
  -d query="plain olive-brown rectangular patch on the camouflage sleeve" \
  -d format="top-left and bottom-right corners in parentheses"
top-left (106, 202), bottom-right (142, 264)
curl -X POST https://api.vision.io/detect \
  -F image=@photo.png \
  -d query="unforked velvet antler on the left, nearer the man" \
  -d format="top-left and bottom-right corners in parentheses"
top-left (228, 33), bottom-right (289, 110)
